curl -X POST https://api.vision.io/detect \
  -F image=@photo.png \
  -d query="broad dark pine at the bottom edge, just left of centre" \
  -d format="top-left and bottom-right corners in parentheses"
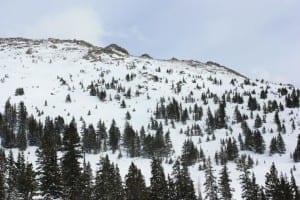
top-left (125, 163), bottom-right (148, 200)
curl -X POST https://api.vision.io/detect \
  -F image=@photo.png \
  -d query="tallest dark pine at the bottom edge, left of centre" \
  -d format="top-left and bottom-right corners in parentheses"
top-left (61, 119), bottom-right (81, 200)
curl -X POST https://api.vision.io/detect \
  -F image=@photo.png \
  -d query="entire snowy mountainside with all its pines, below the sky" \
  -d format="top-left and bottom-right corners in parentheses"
top-left (0, 38), bottom-right (300, 200)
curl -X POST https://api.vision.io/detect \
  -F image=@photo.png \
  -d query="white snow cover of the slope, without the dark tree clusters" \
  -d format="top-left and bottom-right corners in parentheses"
top-left (0, 38), bottom-right (300, 199)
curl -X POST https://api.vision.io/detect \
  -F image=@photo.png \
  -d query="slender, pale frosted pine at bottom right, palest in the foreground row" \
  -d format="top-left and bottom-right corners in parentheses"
top-left (204, 158), bottom-right (218, 200)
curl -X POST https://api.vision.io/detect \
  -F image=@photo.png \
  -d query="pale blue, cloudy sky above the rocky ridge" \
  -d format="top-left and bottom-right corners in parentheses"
top-left (0, 0), bottom-right (300, 87)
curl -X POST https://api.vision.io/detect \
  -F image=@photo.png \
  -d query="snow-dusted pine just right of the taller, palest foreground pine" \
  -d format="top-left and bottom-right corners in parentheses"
top-left (219, 165), bottom-right (233, 200)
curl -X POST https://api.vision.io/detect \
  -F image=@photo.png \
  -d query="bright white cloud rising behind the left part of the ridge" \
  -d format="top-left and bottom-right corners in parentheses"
top-left (26, 8), bottom-right (103, 45)
